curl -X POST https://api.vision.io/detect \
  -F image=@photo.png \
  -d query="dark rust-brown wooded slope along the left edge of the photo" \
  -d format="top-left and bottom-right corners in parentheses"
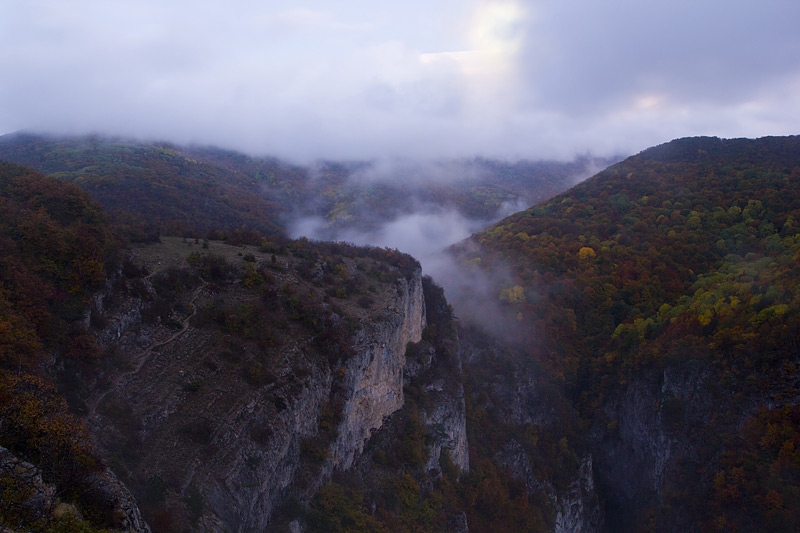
top-left (0, 162), bottom-right (115, 531)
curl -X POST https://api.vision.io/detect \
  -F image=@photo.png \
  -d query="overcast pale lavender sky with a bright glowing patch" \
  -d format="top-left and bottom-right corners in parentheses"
top-left (0, 0), bottom-right (800, 160)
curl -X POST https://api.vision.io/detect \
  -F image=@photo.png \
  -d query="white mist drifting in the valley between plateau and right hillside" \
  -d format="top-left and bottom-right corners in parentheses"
top-left (285, 156), bottom-right (556, 335)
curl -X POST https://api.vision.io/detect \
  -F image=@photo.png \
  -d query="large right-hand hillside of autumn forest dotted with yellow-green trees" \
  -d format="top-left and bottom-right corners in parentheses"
top-left (456, 137), bottom-right (800, 530)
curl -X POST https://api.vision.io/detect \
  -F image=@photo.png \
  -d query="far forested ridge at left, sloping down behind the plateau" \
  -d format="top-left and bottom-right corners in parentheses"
top-left (0, 134), bottom-right (283, 239)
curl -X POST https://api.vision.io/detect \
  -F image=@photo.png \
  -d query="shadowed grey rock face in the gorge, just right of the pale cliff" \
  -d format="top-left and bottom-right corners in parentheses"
top-left (463, 324), bottom-right (604, 533)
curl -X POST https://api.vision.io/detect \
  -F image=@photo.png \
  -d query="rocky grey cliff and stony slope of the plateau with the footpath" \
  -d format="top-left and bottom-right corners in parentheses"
top-left (87, 240), bottom-right (428, 531)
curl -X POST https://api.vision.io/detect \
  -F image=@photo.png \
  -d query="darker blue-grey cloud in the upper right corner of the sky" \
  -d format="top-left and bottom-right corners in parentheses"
top-left (522, 0), bottom-right (800, 115)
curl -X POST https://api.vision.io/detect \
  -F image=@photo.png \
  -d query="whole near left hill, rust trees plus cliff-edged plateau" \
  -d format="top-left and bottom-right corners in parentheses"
top-left (0, 157), bottom-right (482, 532)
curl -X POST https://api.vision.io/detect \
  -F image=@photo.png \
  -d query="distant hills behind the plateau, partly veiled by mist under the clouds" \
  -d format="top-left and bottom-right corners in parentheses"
top-left (0, 133), bottom-right (610, 242)
